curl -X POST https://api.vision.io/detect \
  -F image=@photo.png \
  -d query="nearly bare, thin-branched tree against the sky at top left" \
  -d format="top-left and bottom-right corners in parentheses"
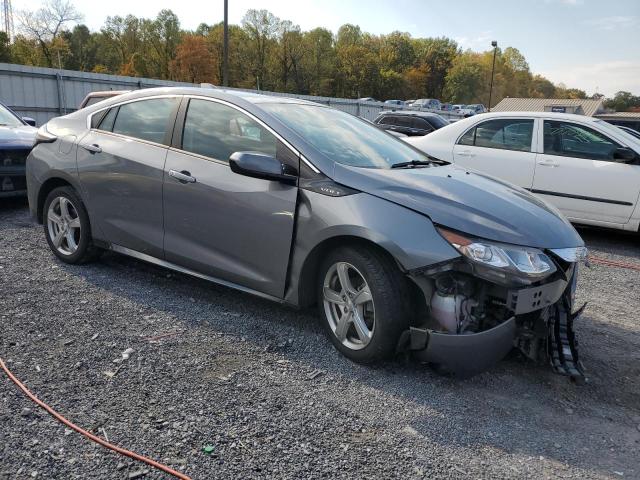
top-left (18, 0), bottom-right (82, 67)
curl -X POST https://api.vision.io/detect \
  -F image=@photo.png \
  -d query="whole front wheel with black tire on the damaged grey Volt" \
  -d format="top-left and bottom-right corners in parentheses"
top-left (317, 247), bottom-right (409, 363)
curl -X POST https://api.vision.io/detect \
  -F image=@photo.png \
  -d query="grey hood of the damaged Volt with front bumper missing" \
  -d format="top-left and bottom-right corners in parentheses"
top-left (333, 163), bottom-right (584, 248)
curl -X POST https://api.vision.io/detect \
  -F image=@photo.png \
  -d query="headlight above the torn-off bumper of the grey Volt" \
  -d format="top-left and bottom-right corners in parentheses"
top-left (438, 228), bottom-right (556, 278)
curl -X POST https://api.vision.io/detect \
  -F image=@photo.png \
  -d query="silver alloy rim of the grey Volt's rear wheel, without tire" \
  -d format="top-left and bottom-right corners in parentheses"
top-left (47, 196), bottom-right (81, 255)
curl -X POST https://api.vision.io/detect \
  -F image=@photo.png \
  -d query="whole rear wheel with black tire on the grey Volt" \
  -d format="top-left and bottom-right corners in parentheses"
top-left (42, 187), bottom-right (101, 265)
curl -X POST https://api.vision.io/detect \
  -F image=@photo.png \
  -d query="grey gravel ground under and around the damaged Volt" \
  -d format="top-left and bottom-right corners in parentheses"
top-left (0, 200), bottom-right (640, 479)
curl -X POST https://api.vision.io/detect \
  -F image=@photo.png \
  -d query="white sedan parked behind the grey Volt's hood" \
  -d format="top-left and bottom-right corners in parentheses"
top-left (403, 112), bottom-right (640, 231)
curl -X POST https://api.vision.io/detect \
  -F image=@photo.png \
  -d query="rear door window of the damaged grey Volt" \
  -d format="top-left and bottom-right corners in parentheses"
top-left (111, 98), bottom-right (178, 143)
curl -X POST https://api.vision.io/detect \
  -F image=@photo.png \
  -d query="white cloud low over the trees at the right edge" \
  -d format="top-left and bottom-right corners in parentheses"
top-left (539, 60), bottom-right (640, 97)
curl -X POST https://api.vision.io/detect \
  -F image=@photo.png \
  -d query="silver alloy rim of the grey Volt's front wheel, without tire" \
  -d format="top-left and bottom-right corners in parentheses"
top-left (322, 262), bottom-right (375, 350)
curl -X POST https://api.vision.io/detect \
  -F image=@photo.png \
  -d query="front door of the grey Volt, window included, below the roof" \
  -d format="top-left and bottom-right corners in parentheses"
top-left (163, 98), bottom-right (299, 297)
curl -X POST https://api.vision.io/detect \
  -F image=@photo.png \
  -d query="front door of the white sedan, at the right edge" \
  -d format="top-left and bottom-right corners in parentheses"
top-left (532, 119), bottom-right (640, 224)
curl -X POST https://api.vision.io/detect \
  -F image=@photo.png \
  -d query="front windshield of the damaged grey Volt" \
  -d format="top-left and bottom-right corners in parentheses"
top-left (261, 103), bottom-right (429, 168)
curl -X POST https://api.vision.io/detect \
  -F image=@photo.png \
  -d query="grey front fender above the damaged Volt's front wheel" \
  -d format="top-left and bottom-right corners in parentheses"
top-left (285, 190), bottom-right (460, 305)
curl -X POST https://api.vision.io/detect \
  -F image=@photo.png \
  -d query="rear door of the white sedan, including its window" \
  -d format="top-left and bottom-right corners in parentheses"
top-left (453, 118), bottom-right (536, 189)
